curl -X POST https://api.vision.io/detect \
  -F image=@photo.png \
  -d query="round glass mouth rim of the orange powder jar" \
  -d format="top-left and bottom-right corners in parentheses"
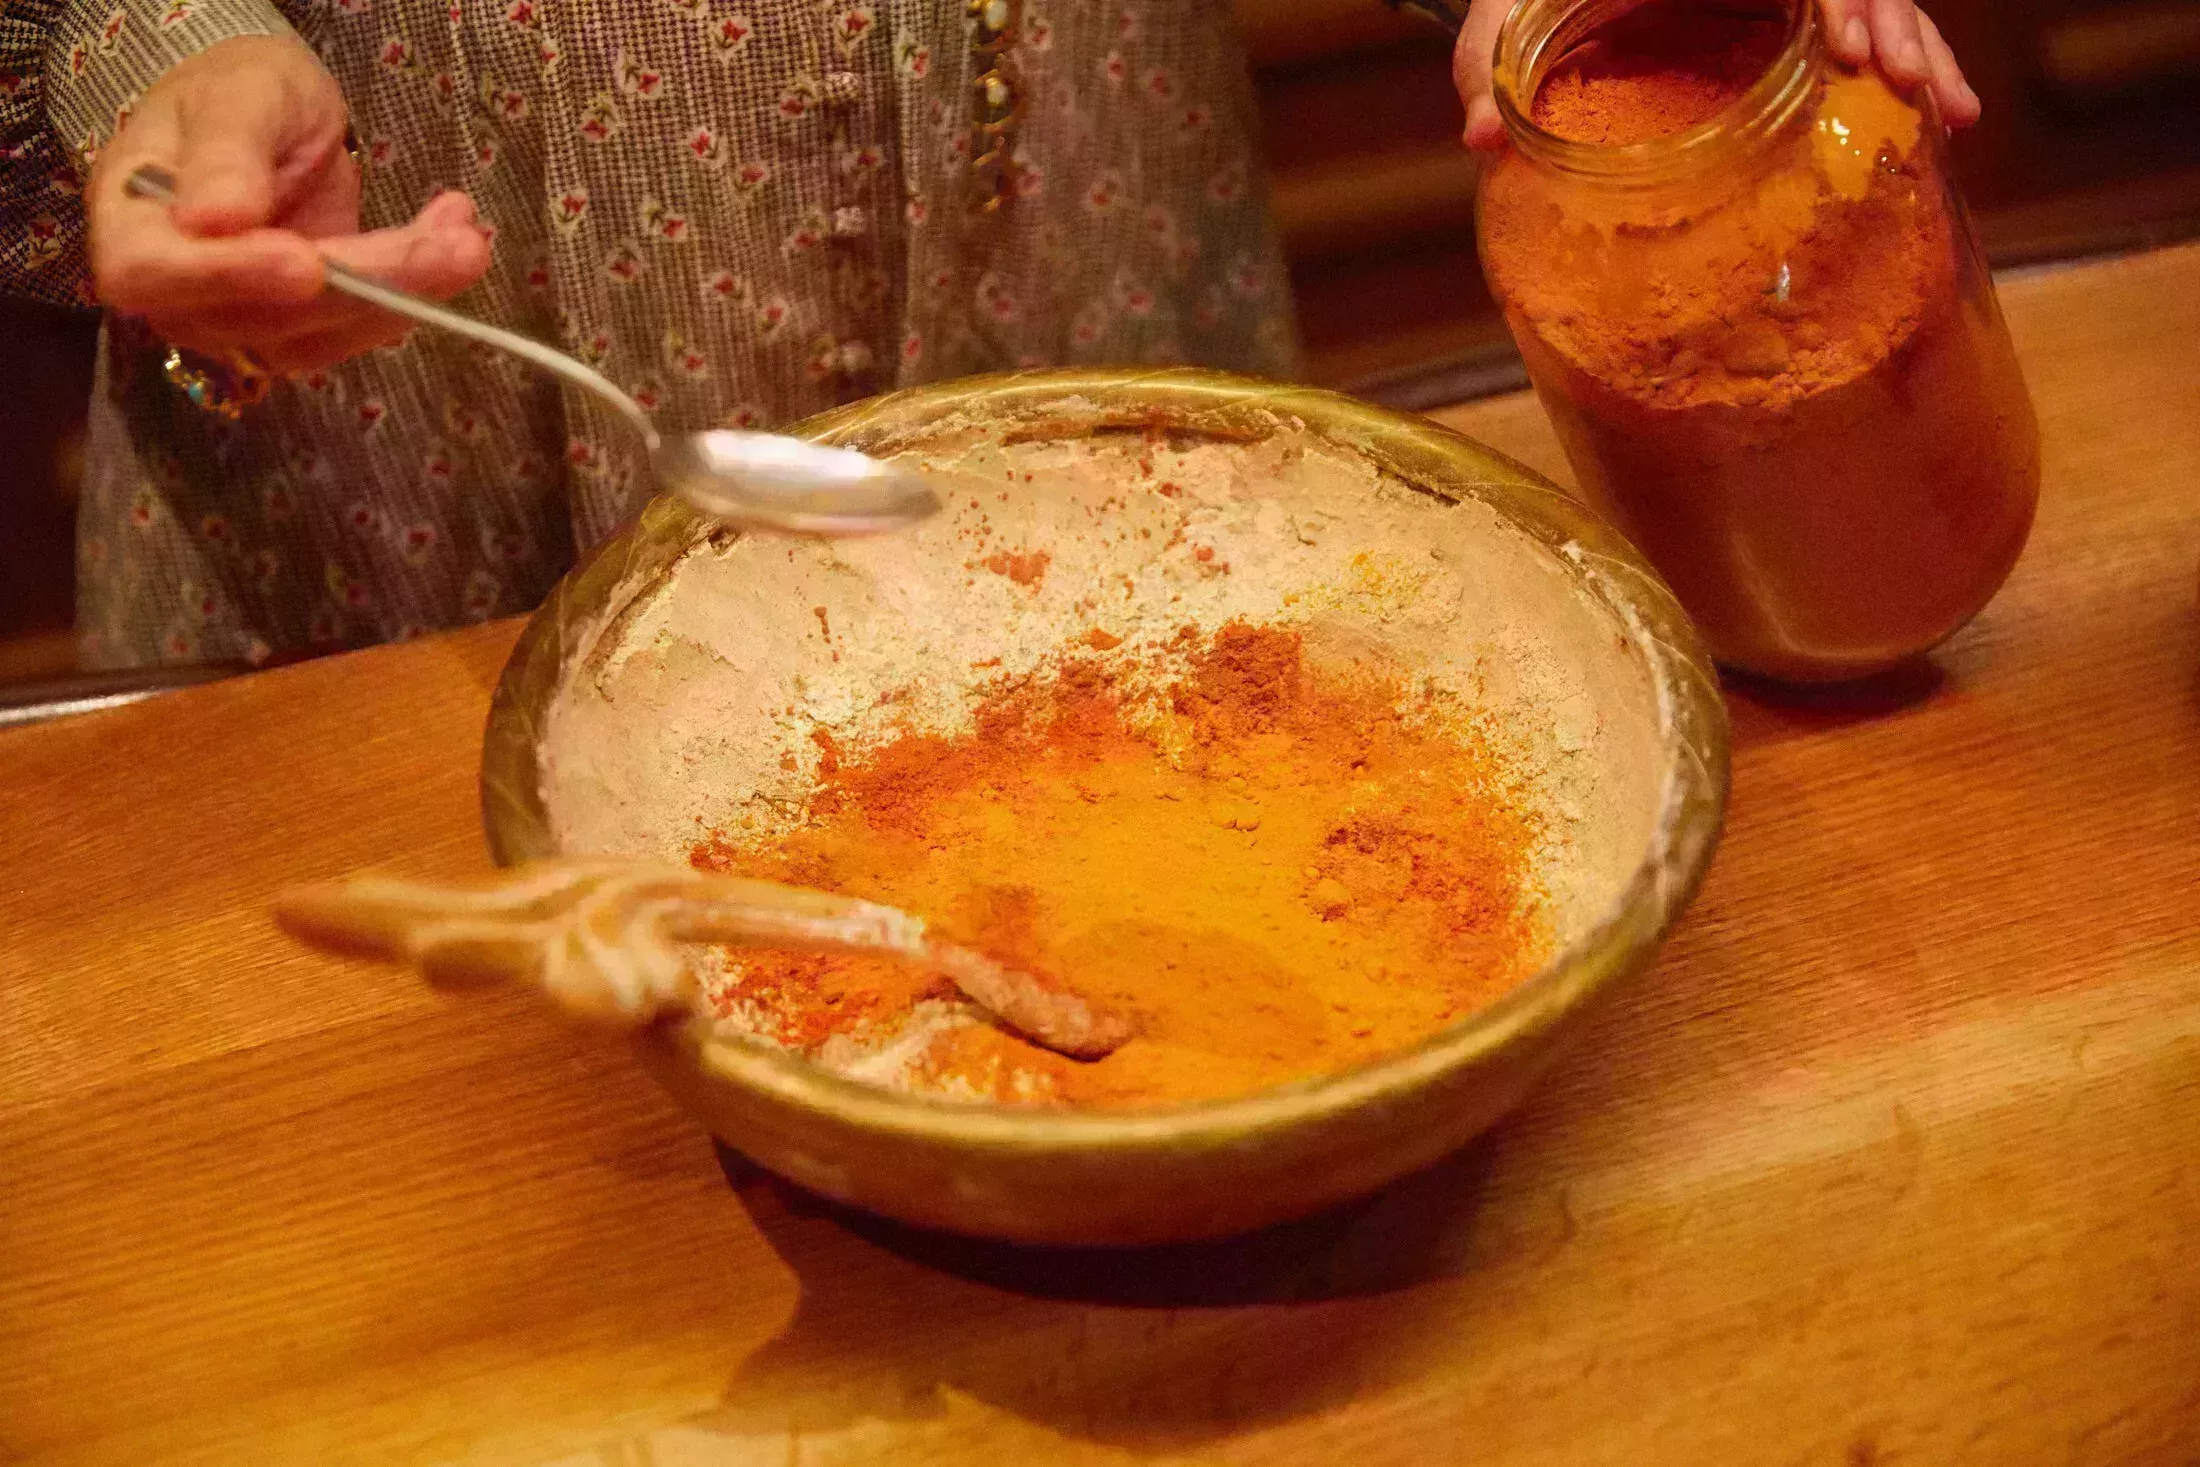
top-left (1492, 0), bottom-right (1824, 187)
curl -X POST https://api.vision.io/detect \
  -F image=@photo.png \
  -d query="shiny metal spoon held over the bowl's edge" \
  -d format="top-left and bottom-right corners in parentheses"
top-left (123, 163), bottom-right (942, 534)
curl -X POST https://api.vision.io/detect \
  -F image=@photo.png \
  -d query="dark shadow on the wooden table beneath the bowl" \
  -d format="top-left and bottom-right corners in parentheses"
top-left (689, 1141), bottom-right (1513, 1447)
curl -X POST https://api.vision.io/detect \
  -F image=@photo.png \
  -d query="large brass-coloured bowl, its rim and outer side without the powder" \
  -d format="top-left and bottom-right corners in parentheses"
top-left (482, 372), bottom-right (1727, 1245)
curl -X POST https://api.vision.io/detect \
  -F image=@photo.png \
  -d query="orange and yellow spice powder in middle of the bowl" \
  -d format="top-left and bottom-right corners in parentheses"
top-left (693, 625), bottom-right (1549, 1106)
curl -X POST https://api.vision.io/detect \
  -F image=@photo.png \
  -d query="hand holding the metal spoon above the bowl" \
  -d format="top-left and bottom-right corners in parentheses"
top-left (86, 35), bottom-right (488, 372)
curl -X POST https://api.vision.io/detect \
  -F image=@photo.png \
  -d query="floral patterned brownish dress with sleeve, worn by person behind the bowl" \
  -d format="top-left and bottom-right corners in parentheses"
top-left (0, 0), bottom-right (1291, 666)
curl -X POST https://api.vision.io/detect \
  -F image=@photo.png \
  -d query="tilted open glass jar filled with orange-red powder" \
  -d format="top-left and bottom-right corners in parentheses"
top-left (1478, 0), bottom-right (2039, 682)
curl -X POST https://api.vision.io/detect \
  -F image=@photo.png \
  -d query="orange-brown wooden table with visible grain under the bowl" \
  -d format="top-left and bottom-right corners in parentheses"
top-left (0, 249), bottom-right (2200, 1467)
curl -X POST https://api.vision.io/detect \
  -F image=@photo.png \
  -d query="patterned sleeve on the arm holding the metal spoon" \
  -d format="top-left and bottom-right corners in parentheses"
top-left (0, 0), bottom-right (290, 306)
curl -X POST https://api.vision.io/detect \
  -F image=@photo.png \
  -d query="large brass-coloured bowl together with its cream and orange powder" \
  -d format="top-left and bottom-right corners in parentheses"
top-left (484, 372), bottom-right (1725, 1243)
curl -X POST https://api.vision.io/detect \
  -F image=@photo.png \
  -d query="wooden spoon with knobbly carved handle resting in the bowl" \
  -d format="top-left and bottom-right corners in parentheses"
top-left (275, 858), bottom-right (1131, 1060)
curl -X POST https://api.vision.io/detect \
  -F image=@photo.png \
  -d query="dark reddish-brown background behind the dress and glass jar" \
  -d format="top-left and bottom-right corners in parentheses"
top-left (0, 0), bottom-right (2200, 682)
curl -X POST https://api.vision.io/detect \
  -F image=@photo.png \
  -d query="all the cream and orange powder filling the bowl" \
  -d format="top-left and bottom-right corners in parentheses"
top-left (539, 418), bottom-right (1670, 1108)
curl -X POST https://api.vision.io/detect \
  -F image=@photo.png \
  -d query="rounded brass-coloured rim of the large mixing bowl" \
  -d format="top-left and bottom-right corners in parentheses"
top-left (482, 367), bottom-right (1729, 1157)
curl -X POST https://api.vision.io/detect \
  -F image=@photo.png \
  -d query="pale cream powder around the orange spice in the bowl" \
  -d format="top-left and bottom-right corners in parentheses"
top-left (541, 424), bottom-right (1665, 1082)
